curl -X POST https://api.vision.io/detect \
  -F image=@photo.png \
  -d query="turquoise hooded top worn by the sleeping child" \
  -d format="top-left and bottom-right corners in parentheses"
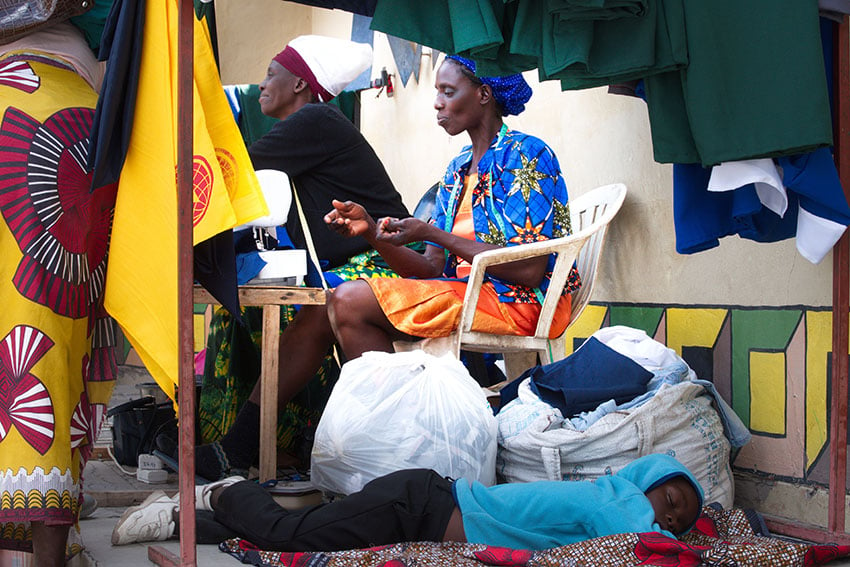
top-left (454, 454), bottom-right (703, 550)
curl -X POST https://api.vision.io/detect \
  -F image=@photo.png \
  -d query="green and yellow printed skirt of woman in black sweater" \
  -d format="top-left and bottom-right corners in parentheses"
top-left (198, 250), bottom-right (398, 454)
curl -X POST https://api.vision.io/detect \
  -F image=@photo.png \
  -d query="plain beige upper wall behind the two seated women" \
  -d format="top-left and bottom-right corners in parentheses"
top-left (216, 5), bottom-right (832, 306)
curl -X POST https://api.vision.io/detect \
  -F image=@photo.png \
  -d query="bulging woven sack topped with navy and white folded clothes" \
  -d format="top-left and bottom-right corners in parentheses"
top-left (496, 327), bottom-right (749, 507)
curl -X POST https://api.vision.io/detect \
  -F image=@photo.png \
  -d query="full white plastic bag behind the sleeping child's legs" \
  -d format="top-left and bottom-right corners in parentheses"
top-left (310, 350), bottom-right (497, 494)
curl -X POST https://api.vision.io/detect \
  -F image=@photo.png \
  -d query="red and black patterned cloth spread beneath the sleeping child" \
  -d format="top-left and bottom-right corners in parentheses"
top-left (220, 507), bottom-right (850, 567)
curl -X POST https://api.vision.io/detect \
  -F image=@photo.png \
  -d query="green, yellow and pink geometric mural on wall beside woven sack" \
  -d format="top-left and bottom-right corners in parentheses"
top-left (567, 304), bottom-right (832, 485)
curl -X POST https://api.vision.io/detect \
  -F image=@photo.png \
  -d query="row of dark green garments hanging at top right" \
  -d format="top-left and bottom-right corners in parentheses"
top-left (372, 0), bottom-right (832, 166)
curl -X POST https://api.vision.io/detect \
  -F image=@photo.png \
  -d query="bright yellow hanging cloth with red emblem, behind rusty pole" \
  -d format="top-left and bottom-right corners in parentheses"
top-left (105, 0), bottom-right (268, 395)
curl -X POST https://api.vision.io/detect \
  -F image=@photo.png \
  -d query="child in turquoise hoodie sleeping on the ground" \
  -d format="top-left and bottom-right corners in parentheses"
top-left (112, 454), bottom-right (703, 551)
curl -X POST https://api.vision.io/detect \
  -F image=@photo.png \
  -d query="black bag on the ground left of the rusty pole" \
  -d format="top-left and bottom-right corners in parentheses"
top-left (106, 396), bottom-right (177, 467)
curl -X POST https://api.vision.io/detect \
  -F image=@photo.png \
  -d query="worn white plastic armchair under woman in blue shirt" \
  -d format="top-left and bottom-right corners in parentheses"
top-left (396, 183), bottom-right (626, 379)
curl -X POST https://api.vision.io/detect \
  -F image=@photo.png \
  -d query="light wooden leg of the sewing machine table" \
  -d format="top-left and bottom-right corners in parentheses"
top-left (260, 305), bottom-right (280, 482)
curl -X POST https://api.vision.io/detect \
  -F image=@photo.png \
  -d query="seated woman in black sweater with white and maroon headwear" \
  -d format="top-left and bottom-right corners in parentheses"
top-left (182, 35), bottom-right (409, 479)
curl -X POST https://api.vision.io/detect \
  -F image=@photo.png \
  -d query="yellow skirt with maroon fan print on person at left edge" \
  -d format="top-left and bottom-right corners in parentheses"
top-left (0, 54), bottom-right (116, 550)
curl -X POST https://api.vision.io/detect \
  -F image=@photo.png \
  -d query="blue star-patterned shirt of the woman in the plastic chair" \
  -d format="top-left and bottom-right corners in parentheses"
top-left (433, 127), bottom-right (581, 303)
